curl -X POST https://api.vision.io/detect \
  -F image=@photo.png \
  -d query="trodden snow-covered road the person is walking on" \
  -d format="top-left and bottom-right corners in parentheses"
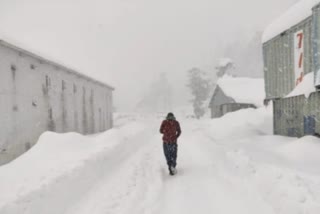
top-left (63, 118), bottom-right (272, 214)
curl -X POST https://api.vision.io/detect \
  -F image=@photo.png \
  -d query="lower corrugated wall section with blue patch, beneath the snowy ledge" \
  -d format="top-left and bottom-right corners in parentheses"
top-left (274, 92), bottom-right (320, 137)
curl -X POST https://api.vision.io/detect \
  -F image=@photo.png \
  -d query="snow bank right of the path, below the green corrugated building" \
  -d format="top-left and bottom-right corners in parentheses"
top-left (201, 108), bottom-right (320, 214)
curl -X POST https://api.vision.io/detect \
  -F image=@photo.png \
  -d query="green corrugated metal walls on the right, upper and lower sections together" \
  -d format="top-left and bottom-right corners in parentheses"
top-left (263, 4), bottom-right (320, 137)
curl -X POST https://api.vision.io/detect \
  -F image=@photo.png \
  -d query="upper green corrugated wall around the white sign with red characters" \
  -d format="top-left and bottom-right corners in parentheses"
top-left (263, 17), bottom-right (313, 99)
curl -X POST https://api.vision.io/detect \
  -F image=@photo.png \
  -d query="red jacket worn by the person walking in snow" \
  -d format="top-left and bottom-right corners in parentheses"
top-left (160, 120), bottom-right (181, 143)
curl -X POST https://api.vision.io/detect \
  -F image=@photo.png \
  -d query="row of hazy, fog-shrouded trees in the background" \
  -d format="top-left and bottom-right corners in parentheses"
top-left (136, 33), bottom-right (263, 118)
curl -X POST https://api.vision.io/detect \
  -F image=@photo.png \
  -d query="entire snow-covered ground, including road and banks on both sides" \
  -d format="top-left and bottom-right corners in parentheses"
top-left (0, 108), bottom-right (320, 214)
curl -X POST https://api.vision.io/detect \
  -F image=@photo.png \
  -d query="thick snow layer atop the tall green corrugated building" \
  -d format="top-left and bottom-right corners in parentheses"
top-left (262, 0), bottom-right (320, 43)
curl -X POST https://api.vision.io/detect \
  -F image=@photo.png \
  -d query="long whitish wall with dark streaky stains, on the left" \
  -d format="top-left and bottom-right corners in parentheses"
top-left (0, 41), bottom-right (113, 164)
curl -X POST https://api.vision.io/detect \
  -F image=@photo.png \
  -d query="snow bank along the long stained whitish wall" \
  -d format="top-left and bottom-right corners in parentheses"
top-left (0, 119), bottom-right (145, 213)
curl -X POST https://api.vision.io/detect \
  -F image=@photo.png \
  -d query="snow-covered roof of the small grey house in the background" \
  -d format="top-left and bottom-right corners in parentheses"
top-left (217, 75), bottom-right (265, 107)
